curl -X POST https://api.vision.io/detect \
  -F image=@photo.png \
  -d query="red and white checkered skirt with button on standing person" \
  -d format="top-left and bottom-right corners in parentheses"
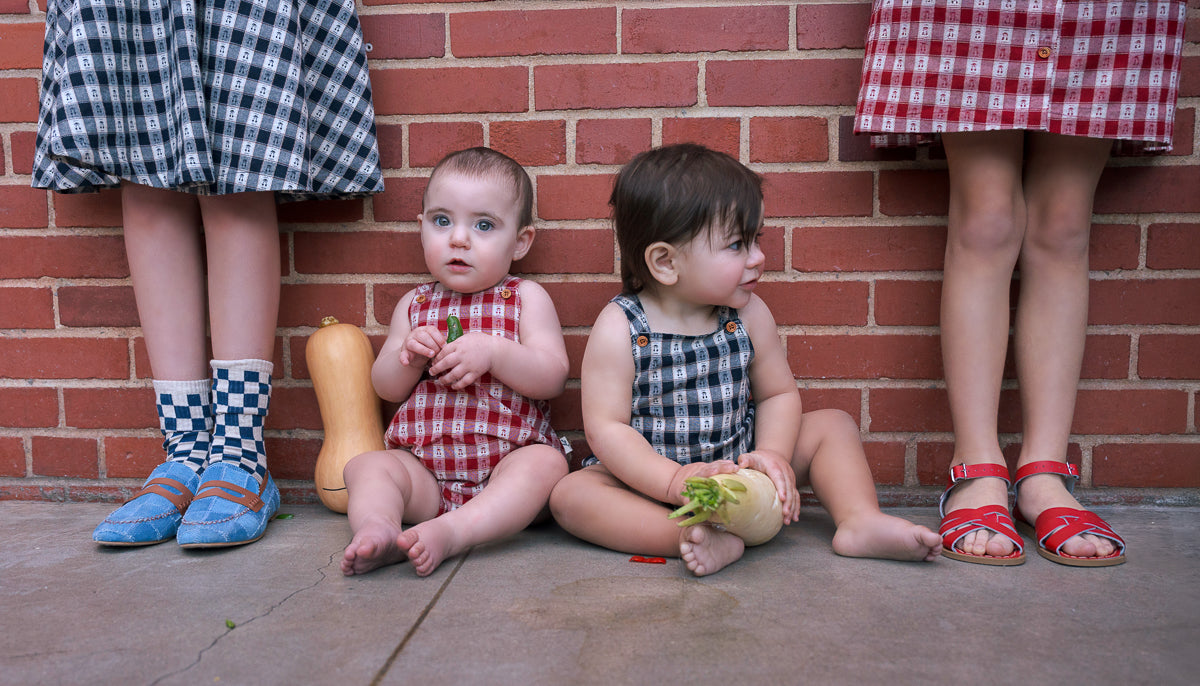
top-left (854, 0), bottom-right (1187, 151)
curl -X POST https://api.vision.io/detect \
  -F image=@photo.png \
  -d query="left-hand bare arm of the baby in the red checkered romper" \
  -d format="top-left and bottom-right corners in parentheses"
top-left (371, 290), bottom-right (445, 402)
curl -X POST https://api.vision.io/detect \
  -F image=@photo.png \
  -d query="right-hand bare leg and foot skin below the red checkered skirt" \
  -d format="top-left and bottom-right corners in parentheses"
top-left (1016, 134), bottom-right (1112, 556)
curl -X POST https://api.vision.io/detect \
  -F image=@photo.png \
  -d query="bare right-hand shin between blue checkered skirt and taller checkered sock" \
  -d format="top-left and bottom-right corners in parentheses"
top-left (199, 187), bottom-right (281, 360)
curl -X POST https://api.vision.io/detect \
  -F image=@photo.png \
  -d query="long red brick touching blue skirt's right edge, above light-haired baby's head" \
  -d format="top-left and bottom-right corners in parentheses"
top-left (371, 67), bottom-right (529, 115)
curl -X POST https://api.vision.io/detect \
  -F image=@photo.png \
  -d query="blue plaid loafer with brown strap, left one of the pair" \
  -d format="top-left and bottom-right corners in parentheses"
top-left (91, 462), bottom-right (200, 546)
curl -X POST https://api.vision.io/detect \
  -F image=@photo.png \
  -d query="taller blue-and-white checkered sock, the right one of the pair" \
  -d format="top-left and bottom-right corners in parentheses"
top-left (209, 360), bottom-right (275, 482)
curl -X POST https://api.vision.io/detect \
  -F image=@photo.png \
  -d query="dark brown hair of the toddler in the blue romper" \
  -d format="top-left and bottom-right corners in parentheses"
top-left (608, 143), bottom-right (762, 293)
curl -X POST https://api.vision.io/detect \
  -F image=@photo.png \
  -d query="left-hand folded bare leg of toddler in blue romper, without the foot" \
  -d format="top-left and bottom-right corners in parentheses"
top-left (550, 464), bottom-right (680, 558)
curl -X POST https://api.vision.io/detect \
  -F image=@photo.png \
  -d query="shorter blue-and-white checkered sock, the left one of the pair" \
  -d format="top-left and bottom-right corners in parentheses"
top-left (154, 379), bottom-right (212, 473)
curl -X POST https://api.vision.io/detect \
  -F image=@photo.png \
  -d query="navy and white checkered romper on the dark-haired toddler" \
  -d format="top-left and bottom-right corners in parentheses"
top-left (613, 295), bottom-right (755, 464)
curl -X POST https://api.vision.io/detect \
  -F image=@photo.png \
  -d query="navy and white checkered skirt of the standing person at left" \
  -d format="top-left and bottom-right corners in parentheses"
top-left (32, 0), bottom-right (383, 200)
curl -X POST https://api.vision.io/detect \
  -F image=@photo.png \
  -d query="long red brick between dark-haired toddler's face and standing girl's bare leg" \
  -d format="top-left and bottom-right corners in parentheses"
top-left (792, 225), bottom-right (946, 271)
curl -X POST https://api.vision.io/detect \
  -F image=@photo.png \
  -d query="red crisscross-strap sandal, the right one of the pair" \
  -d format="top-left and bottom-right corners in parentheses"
top-left (1013, 459), bottom-right (1126, 567)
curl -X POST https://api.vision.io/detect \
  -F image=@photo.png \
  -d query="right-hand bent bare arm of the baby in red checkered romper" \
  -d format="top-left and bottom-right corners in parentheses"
top-left (430, 279), bottom-right (568, 399)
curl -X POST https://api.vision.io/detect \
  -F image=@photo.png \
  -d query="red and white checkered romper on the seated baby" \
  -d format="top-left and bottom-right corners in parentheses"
top-left (385, 276), bottom-right (562, 512)
